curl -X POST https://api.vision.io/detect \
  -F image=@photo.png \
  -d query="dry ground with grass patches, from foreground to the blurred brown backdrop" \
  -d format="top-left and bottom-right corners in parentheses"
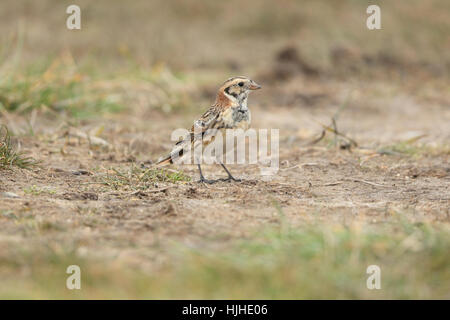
top-left (0, 2), bottom-right (450, 299)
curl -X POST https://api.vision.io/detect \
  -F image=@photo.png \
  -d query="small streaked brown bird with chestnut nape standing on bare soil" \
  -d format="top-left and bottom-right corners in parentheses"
top-left (155, 76), bottom-right (261, 184)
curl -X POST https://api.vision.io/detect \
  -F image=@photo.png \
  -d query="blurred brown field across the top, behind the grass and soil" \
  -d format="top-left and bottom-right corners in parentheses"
top-left (1, 0), bottom-right (450, 71)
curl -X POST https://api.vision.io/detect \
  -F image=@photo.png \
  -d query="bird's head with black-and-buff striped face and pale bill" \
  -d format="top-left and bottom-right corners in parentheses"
top-left (217, 77), bottom-right (261, 105)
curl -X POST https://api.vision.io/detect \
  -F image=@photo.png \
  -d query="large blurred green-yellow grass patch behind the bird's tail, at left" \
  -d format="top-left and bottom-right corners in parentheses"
top-left (0, 56), bottom-right (195, 118)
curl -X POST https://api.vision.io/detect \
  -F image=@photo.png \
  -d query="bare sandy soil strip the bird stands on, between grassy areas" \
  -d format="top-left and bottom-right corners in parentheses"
top-left (0, 70), bottom-right (450, 276)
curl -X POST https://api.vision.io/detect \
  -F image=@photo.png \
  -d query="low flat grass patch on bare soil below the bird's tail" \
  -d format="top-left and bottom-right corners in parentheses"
top-left (101, 166), bottom-right (191, 191)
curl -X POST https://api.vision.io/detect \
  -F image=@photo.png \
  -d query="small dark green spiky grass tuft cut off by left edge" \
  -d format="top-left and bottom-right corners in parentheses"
top-left (0, 125), bottom-right (38, 169)
